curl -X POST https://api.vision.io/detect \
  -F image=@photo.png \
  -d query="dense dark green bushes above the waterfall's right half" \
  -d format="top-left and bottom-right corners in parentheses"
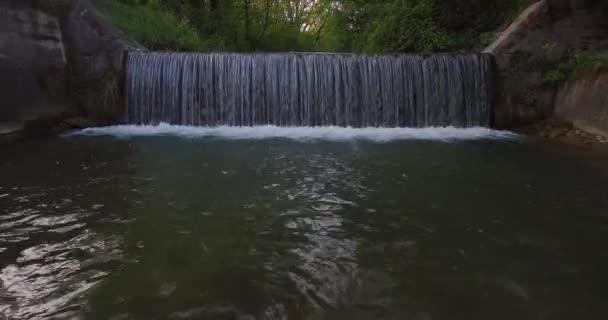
top-left (324, 0), bottom-right (532, 52)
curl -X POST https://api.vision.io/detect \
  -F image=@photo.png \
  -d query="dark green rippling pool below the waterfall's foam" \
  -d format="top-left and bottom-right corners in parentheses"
top-left (0, 132), bottom-right (608, 320)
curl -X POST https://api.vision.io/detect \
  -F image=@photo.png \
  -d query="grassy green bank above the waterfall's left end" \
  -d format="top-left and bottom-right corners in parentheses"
top-left (95, 0), bottom-right (206, 51)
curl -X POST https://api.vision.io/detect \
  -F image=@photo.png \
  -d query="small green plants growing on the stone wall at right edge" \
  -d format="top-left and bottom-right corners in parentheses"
top-left (545, 51), bottom-right (608, 84)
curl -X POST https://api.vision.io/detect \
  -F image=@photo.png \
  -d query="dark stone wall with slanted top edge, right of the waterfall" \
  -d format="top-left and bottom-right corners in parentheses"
top-left (486, 0), bottom-right (608, 128)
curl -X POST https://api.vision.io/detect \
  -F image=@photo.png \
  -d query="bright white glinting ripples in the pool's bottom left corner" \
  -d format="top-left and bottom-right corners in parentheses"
top-left (0, 187), bottom-right (122, 319)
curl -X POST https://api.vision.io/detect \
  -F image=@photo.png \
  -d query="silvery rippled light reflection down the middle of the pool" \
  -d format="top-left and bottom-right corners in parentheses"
top-left (284, 157), bottom-right (362, 309)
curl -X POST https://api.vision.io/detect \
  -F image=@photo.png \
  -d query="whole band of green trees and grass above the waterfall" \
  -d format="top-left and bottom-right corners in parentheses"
top-left (97, 0), bottom-right (532, 53)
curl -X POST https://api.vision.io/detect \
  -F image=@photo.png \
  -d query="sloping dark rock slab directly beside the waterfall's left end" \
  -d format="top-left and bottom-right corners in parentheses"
top-left (59, 0), bottom-right (142, 124)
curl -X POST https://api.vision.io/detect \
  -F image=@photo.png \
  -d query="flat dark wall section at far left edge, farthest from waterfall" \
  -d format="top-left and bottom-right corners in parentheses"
top-left (0, 1), bottom-right (70, 134)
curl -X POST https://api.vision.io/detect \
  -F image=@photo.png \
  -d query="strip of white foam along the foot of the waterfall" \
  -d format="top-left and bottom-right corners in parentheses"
top-left (68, 123), bottom-right (517, 142)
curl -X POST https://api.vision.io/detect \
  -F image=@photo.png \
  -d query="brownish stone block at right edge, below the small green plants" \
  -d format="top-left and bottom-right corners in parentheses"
top-left (555, 73), bottom-right (608, 138)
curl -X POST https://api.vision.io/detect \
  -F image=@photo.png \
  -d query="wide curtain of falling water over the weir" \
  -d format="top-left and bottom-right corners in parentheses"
top-left (126, 52), bottom-right (493, 127)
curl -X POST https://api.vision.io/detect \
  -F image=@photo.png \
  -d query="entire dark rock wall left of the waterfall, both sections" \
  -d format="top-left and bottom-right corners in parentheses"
top-left (0, 0), bottom-right (139, 133)
